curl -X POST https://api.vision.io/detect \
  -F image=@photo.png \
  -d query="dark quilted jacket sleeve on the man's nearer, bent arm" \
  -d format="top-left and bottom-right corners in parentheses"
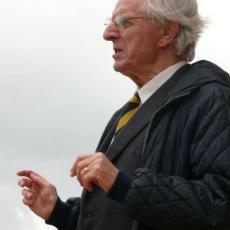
top-left (109, 92), bottom-right (230, 230)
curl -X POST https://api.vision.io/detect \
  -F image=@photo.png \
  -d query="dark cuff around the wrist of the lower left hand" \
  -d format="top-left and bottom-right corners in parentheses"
top-left (45, 197), bottom-right (72, 229)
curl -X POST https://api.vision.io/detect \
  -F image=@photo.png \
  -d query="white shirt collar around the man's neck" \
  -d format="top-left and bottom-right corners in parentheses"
top-left (137, 61), bottom-right (186, 104)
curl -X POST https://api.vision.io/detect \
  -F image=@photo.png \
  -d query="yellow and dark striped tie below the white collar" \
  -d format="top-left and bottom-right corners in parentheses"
top-left (115, 93), bottom-right (140, 135)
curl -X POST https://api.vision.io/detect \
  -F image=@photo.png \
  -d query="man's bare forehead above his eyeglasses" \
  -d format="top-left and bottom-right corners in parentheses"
top-left (113, 0), bottom-right (145, 15)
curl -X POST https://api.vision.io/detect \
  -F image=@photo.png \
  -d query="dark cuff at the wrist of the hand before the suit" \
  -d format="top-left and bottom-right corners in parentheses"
top-left (107, 171), bottom-right (132, 204)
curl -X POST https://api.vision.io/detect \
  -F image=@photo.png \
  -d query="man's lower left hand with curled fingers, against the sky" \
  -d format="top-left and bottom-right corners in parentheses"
top-left (17, 170), bottom-right (57, 220)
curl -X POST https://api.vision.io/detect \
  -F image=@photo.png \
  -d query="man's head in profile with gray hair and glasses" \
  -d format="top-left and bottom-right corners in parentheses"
top-left (104, 0), bottom-right (203, 86)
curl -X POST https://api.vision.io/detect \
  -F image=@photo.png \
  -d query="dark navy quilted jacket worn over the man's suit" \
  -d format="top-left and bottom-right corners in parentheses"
top-left (48, 61), bottom-right (230, 230)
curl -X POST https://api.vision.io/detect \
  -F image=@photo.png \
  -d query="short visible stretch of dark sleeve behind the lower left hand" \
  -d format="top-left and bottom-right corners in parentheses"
top-left (46, 197), bottom-right (80, 230)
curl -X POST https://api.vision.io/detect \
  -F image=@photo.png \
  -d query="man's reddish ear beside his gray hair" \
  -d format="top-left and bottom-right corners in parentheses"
top-left (159, 21), bottom-right (180, 48)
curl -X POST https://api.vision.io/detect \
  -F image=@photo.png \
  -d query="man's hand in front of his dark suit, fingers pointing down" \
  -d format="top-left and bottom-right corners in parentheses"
top-left (70, 152), bottom-right (119, 192)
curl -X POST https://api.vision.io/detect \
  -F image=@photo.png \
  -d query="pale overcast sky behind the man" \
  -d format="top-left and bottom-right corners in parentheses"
top-left (0, 0), bottom-right (230, 230)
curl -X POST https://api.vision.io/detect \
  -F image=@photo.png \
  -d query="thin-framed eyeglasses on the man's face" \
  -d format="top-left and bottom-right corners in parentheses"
top-left (104, 15), bottom-right (144, 30)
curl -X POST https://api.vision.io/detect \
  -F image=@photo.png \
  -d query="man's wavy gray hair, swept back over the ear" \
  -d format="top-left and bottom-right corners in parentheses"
top-left (142, 0), bottom-right (205, 61)
